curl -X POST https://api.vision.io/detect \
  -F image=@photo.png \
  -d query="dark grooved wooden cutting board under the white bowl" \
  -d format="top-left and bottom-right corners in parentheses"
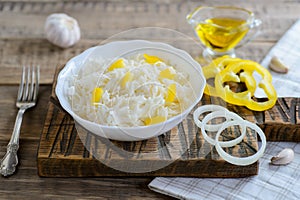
top-left (37, 65), bottom-right (300, 177)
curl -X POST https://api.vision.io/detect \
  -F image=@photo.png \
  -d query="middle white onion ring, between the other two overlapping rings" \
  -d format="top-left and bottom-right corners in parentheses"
top-left (201, 110), bottom-right (246, 147)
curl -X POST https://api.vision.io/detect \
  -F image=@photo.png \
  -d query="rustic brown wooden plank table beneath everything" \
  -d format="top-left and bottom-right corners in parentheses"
top-left (0, 0), bottom-right (300, 199)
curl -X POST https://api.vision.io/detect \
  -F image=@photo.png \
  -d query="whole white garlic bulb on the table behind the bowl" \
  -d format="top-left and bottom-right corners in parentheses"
top-left (45, 13), bottom-right (80, 48)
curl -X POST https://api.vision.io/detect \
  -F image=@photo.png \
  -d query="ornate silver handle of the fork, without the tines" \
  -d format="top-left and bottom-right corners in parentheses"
top-left (0, 108), bottom-right (25, 176)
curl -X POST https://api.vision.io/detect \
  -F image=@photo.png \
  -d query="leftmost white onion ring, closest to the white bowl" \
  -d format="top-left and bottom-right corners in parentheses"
top-left (193, 104), bottom-right (231, 131)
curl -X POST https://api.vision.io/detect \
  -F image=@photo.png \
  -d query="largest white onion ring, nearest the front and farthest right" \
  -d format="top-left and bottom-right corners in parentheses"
top-left (215, 120), bottom-right (267, 166)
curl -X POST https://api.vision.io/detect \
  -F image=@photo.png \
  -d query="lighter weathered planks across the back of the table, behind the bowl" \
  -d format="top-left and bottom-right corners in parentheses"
top-left (0, 0), bottom-right (300, 84)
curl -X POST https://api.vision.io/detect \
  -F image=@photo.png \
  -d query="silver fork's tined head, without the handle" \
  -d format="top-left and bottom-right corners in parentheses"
top-left (17, 66), bottom-right (40, 102)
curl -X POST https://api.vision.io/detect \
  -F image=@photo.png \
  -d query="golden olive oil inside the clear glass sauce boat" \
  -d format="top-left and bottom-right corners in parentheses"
top-left (195, 18), bottom-right (249, 52)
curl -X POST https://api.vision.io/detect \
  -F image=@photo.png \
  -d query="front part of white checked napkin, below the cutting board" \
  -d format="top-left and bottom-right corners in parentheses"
top-left (149, 142), bottom-right (300, 200)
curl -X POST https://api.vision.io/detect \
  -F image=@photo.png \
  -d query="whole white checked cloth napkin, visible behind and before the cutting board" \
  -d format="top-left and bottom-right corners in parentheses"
top-left (149, 20), bottom-right (300, 200)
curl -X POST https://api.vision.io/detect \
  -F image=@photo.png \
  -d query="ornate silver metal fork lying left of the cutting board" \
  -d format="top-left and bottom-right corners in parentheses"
top-left (0, 67), bottom-right (40, 176)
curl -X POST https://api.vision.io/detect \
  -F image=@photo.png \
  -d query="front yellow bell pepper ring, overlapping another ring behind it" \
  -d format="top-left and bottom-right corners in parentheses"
top-left (215, 61), bottom-right (277, 111)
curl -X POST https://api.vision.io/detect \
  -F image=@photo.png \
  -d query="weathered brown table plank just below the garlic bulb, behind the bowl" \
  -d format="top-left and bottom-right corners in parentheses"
top-left (0, 39), bottom-right (272, 85)
